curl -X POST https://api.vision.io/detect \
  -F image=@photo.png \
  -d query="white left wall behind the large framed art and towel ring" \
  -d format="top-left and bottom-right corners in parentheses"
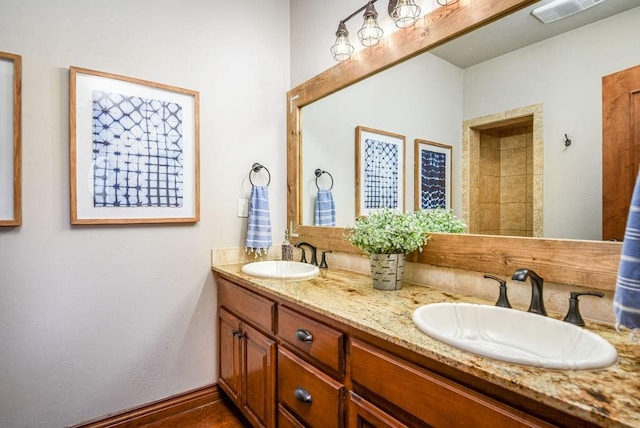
top-left (0, 0), bottom-right (290, 428)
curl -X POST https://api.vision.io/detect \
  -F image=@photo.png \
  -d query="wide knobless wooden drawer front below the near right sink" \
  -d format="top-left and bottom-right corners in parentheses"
top-left (351, 340), bottom-right (550, 428)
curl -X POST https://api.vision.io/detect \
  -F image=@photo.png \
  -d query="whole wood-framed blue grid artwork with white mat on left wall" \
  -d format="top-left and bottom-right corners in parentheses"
top-left (69, 67), bottom-right (200, 224)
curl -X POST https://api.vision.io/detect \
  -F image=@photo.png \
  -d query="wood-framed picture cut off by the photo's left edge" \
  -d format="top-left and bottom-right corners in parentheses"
top-left (0, 52), bottom-right (22, 226)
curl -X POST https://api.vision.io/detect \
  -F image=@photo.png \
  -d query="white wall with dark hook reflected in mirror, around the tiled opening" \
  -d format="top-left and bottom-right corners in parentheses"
top-left (464, 8), bottom-right (640, 240)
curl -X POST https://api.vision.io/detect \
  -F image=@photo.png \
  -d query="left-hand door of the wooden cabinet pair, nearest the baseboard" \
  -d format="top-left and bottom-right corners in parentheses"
top-left (218, 308), bottom-right (242, 404)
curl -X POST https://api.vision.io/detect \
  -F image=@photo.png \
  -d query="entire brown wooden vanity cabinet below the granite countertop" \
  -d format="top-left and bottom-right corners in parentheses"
top-left (217, 275), bottom-right (590, 428)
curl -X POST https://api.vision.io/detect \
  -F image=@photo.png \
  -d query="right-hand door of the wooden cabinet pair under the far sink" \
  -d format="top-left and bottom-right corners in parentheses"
top-left (242, 324), bottom-right (276, 427)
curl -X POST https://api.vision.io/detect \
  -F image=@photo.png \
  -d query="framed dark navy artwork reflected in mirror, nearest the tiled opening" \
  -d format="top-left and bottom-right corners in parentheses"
top-left (414, 139), bottom-right (451, 210)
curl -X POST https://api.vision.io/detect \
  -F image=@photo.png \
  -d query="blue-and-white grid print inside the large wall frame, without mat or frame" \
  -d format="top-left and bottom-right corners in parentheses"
top-left (92, 90), bottom-right (184, 207)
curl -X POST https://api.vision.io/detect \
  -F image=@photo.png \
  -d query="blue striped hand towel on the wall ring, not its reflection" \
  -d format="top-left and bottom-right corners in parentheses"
top-left (246, 186), bottom-right (271, 257)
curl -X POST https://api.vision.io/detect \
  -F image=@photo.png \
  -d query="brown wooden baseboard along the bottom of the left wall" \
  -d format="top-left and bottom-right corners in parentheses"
top-left (72, 384), bottom-right (224, 428)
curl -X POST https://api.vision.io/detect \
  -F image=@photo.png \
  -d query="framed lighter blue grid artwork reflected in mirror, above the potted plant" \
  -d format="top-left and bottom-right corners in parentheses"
top-left (355, 126), bottom-right (405, 216)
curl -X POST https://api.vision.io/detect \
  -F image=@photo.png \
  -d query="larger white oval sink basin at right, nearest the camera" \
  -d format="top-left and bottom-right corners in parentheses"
top-left (413, 303), bottom-right (618, 370)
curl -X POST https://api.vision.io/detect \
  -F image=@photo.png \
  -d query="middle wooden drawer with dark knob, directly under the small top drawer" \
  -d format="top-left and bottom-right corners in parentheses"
top-left (278, 348), bottom-right (344, 428)
